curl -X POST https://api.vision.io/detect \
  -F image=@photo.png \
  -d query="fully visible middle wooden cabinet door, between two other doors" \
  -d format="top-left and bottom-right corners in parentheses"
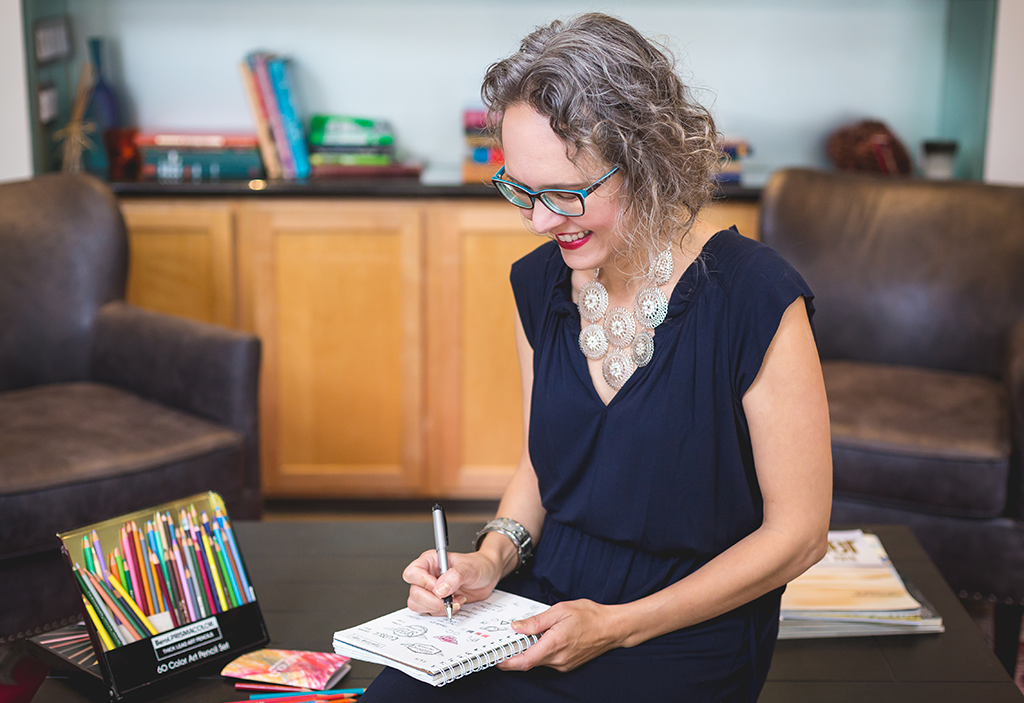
top-left (239, 201), bottom-right (423, 497)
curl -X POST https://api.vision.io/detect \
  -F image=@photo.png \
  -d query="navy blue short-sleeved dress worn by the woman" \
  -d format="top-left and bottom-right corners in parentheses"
top-left (364, 229), bottom-right (813, 703)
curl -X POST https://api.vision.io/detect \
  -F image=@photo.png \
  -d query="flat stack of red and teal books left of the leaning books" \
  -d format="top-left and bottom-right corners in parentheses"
top-left (135, 132), bottom-right (264, 183)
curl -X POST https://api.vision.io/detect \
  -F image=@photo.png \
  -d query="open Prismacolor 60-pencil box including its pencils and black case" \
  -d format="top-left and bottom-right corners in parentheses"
top-left (32, 492), bottom-right (269, 699)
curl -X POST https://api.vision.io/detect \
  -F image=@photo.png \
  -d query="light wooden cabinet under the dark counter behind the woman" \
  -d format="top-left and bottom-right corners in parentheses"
top-left (123, 199), bottom-right (757, 498)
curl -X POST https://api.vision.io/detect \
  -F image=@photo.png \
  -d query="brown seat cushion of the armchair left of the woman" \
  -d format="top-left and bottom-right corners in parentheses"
top-left (0, 383), bottom-right (245, 557)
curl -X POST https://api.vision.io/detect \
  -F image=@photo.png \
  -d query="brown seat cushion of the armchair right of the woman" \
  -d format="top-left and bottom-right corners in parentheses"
top-left (822, 361), bottom-right (1011, 518)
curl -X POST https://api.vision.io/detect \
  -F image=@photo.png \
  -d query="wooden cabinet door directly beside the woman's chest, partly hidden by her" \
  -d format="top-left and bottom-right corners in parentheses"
top-left (427, 203), bottom-right (544, 498)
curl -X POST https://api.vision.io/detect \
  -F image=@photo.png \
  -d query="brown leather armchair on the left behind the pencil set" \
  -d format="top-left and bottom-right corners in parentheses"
top-left (0, 175), bottom-right (262, 641)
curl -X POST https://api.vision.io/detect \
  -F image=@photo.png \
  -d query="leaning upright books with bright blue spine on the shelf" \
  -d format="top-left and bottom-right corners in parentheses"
top-left (240, 51), bottom-right (310, 179)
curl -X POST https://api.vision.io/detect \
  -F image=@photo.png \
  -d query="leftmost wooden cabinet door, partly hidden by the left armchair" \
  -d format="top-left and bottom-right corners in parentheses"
top-left (121, 200), bottom-right (237, 326)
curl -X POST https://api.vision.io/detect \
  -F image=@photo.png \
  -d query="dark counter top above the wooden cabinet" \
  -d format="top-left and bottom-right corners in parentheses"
top-left (110, 178), bottom-right (761, 202)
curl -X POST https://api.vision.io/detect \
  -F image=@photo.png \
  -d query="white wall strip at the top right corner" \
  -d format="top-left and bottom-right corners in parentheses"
top-left (985, 0), bottom-right (1024, 185)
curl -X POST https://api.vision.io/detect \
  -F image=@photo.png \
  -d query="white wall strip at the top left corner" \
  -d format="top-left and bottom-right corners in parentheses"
top-left (0, 0), bottom-right (32, 181)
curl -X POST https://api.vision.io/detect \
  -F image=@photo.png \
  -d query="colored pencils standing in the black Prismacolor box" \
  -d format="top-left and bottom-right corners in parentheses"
top-left (73, 504), bottom-right (256, 650)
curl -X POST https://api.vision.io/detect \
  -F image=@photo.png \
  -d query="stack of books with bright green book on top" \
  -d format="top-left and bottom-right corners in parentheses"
top-left (309, 115), bottom-right (421, 178)
